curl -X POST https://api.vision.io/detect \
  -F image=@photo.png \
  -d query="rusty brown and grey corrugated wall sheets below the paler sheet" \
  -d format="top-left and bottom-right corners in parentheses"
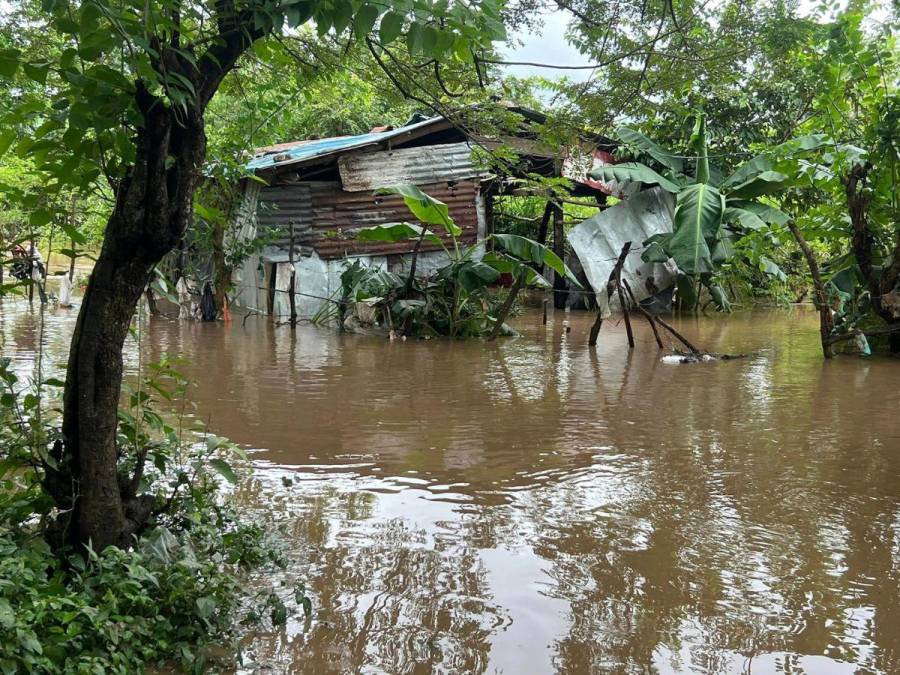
top-left (257, 181), bottom-right (478, 259)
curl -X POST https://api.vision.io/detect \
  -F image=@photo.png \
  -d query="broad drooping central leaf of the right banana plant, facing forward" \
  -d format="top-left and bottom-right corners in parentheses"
top-left (666, 183), bottom-right (725, 275)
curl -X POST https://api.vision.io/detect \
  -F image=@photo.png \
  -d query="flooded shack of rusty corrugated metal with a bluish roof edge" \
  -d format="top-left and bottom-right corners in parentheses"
top-left (224, 106), bottom-right (672, 318)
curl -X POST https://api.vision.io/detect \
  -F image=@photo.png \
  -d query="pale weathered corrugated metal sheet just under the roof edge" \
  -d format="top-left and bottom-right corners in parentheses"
top-left (338, 143), bottom-right (487, 192)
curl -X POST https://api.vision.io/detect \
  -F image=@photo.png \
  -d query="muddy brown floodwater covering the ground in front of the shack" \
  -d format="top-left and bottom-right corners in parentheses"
top-left (0, 301), bottom-right (900, 675)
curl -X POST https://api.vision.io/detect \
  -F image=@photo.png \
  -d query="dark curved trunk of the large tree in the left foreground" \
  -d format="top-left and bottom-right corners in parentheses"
top-left (47, 104), bottom-right (206, 551)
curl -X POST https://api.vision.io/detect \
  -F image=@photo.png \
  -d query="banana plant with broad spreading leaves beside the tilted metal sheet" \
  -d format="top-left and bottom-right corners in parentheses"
top-left (591, 113), bottom-right (808, 311)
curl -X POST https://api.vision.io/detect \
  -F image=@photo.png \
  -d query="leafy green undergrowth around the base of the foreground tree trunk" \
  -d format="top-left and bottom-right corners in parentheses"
top-left (0, 359), bottom-right (310, 675)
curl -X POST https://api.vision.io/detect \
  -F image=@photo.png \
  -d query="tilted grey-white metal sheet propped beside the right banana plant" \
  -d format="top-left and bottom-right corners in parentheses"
top-left (568, 188), bottom-right (675, 310)
